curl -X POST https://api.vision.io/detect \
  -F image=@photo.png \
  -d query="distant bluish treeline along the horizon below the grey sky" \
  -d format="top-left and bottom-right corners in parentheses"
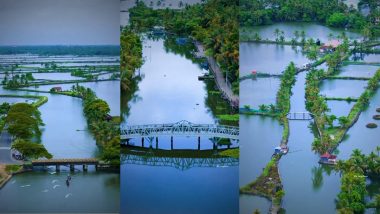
top-left (0, 45), bottom-right (120, 56)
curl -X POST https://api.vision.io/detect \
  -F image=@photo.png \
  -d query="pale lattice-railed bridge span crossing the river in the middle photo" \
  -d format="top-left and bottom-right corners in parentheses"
top-left (120, 120), bottom-right (239, 141)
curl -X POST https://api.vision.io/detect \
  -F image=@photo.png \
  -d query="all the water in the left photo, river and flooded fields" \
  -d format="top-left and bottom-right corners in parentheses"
top-left (0, 55), bottom-right (120, 213)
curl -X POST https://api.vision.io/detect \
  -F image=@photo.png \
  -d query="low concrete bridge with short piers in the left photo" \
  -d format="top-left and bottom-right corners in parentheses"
top-left (32, 158), bottom-right (99, 171)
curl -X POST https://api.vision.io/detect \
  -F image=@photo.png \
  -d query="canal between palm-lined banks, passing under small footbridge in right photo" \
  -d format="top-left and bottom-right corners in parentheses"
top-left (279, 72), bottom-right (340, 213)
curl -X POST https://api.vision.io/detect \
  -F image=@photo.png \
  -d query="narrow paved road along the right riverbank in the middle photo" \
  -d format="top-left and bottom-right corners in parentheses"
top-left (195, 41), bottom-right (239, 107)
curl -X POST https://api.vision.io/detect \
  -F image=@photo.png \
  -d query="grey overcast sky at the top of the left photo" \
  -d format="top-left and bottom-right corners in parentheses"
top-left (0, 0), bottom-right (120, 45)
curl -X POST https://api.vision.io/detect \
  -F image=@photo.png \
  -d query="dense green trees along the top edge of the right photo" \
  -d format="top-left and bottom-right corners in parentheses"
top-left (240, 0), bottom-right (380, 36)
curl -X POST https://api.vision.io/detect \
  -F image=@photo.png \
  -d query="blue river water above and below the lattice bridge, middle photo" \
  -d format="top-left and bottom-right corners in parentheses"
top-left (121, 39), bottom-right (239, 214)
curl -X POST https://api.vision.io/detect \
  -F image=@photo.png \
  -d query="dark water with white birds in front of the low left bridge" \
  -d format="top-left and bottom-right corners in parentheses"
top-left (0, 167), bottom-right (120, 213)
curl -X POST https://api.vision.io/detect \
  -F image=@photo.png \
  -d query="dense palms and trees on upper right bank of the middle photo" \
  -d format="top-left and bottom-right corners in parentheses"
top-left (130, 0), bottom-right (239, 92)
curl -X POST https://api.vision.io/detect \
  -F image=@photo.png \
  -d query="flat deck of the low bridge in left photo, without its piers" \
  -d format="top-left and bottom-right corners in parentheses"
top-left (32, 158), bottom-right (99, 166)
